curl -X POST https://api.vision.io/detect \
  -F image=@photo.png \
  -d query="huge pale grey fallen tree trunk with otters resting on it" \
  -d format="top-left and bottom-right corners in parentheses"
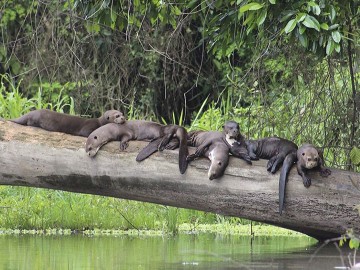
top-left (0, 121), bottom-right (360, 240)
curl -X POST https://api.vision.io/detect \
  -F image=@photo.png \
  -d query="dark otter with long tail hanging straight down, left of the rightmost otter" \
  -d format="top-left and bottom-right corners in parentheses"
top-left (246, 137), bottom-right (298, 215)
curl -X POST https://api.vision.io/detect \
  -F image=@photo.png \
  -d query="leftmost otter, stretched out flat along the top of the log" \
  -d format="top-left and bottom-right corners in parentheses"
top-left (10, 109), bottom-right (125, 137)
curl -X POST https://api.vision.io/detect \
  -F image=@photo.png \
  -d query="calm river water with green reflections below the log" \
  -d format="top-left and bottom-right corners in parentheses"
top-left (0, 233), bottom-right (359, 270)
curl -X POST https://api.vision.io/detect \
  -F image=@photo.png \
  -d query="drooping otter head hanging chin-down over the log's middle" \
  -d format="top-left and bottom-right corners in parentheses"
top-left (208, 147), bottom-right (229, 180)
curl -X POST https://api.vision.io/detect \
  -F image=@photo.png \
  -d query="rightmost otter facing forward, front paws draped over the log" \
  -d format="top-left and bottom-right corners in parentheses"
top-left (296, 143), bottom-right (331, 187)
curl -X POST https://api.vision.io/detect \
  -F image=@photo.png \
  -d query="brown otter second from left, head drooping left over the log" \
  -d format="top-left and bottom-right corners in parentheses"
top-left (85, 120), bottom-right (188, 174)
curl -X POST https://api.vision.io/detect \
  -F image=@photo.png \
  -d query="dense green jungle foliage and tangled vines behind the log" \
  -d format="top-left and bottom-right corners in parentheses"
top-left (0, 0), bottom-right (360, 235)
